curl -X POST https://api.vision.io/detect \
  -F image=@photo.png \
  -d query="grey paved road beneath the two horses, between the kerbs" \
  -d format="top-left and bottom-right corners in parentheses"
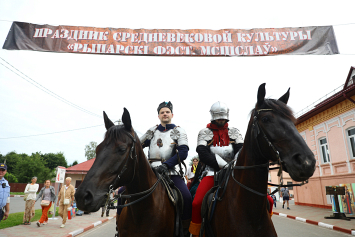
top-left (77, 215), bottom-right (351, 237)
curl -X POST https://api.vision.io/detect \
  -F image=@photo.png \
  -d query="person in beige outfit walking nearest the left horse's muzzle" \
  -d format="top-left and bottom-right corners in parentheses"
top-left (57, 177), bottom-right (75, 228)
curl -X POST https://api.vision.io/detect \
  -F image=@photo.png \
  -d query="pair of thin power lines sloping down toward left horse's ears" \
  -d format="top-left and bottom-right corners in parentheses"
top-left (0, 57), bottom-right (102, 118)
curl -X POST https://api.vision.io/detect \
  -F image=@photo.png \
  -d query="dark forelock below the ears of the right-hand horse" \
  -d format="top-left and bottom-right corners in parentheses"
top-left (250, 99), bottom-right (297, 123)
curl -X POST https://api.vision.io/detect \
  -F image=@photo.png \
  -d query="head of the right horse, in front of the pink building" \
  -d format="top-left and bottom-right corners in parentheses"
top-left (252, 83), bottom-right (316, 181)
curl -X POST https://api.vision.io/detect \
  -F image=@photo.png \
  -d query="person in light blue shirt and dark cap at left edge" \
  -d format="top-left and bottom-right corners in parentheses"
top-left (0, 163), bottom-right (10, 222)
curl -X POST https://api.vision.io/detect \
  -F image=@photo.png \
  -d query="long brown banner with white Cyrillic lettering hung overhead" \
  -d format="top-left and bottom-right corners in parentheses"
top-left (3, 22), bottom-right (339, 56)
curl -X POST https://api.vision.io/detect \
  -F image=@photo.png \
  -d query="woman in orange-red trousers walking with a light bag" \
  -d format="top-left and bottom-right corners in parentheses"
top-left (36, 179), bottom-right (56, 227)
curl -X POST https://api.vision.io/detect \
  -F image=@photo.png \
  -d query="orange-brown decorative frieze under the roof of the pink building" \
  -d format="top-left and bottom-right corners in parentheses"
top-left (296, 99), bottom-right (355, 132)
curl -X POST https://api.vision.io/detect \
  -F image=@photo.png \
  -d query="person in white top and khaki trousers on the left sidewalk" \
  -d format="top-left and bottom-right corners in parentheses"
top-left (23, 177), bottom-right (39, 225)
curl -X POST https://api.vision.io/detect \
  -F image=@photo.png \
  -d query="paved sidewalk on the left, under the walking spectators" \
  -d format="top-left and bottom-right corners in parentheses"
top-left (0, 209), bottom-right (116, 237)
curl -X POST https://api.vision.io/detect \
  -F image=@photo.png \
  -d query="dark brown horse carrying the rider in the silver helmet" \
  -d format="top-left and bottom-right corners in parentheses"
top-left (211, 84), bottom-right (316, 237)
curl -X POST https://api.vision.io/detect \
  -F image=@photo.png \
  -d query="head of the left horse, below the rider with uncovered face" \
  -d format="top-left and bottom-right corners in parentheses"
top-left (75, 108), bottom-right (140, 212)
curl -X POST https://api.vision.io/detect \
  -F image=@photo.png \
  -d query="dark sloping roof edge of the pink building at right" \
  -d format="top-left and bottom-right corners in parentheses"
top-left (296, 67), bottom-right (355, 125)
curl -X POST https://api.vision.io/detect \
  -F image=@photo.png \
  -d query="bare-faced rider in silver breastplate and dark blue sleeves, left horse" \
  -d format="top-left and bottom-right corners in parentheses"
top-left (140, 101), bottom-right (192, 236)
